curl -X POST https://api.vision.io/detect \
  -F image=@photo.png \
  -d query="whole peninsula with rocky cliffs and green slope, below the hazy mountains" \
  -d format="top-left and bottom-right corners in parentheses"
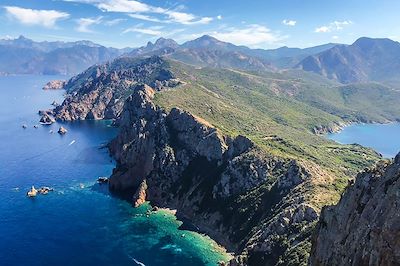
top-left (46, 56), bottom-right (400, 265)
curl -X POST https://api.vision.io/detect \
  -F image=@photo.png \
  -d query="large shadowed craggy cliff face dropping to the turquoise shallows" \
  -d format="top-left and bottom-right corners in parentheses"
top-left (109, 85), bottom-right (324, 265)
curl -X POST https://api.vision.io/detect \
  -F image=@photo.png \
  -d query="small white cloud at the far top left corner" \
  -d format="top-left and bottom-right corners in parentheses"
top-left (4, 6), bottom-right (70, 28)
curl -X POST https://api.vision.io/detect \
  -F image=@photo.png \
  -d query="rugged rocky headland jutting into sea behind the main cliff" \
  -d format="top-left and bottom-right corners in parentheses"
top-left (54, 56), bottom-right (179, 121)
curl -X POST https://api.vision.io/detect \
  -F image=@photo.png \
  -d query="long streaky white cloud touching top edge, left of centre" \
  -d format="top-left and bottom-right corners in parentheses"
top-left (64, 0), bottom-right (213, 25)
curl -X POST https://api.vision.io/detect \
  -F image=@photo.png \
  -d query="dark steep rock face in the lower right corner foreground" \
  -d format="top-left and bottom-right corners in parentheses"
top-left (310, 154), bottom-right (400, 265)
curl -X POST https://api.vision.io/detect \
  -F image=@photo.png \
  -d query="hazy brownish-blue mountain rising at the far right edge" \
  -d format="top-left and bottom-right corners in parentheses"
top-left (297, 37), bottom-right (400, 83)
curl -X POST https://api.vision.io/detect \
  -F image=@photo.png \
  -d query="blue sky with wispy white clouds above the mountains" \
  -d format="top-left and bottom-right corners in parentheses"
top-left (0, 0), bottom-right (400, 48)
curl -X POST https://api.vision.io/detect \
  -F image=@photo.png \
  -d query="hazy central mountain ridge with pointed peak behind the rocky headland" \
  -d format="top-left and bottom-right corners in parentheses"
top-left (128, 35), bottom-right (333, 71)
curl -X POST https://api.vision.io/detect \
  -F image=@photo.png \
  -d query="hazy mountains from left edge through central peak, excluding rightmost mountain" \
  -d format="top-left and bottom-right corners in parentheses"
top-left (0, 35), bottom-right (335, 75)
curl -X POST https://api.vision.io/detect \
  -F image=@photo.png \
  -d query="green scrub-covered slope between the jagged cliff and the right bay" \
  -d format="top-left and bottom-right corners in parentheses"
top-left (156, 61), bottom-right (400, 206)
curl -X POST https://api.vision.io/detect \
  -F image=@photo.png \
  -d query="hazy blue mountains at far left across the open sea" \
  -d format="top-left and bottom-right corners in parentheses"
top-left (0, 36), bottom-right (128, 75)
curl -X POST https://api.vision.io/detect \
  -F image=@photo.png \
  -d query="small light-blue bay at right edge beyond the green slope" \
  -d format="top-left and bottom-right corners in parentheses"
top-left (327, 123), bottom-right (400, 158)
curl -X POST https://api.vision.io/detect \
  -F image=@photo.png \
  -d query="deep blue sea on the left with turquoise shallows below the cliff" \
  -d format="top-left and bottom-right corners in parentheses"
top-left (0, 76), bottom-right (226, 266)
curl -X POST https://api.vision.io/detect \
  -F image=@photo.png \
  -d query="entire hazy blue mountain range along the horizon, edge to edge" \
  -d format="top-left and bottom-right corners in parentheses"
top-left (0, 35), bottom-right (400, 87)
